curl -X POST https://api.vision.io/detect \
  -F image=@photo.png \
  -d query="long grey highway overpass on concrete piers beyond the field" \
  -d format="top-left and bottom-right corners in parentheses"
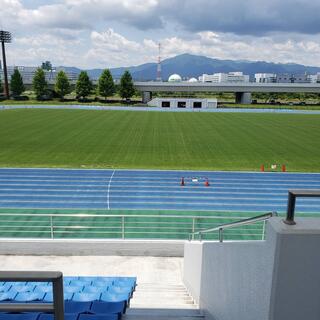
top-left (135, 82), bottom-right (320, 104)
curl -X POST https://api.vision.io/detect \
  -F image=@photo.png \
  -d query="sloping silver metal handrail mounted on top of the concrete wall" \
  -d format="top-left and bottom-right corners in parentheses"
top-left (189, 212), bottom-right (278, 242)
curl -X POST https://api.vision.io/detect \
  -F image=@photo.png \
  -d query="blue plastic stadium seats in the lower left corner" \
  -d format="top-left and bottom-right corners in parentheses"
top-left (0, 277), bottom-right (137, 320)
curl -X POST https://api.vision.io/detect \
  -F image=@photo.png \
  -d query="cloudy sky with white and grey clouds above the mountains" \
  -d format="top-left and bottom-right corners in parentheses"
top-left (0, 0), bottom-right (320, 68)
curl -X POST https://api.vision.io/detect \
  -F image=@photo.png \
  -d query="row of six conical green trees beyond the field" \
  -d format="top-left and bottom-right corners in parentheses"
top-left (10, 68), bottom-right (135, 101)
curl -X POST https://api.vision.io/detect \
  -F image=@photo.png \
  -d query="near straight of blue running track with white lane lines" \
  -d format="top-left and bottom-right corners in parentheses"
top-left (0, 169), bottom-right (320, 213)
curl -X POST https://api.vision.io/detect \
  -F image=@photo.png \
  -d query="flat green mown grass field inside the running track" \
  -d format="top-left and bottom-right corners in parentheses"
top-left (0, 109), bottom-right (320, 172)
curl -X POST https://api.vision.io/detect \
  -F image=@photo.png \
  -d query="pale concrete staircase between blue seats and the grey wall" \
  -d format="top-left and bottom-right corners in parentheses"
top-left (123, 283), bottom-right (204, 320)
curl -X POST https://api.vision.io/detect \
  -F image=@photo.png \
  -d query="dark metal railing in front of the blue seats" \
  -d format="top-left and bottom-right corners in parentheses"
top-left (0, 271), bottom-right (64, 320)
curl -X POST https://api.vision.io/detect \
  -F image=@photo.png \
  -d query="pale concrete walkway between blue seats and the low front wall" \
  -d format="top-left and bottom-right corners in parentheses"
top-left (0, 255), bottom-right (183, 285)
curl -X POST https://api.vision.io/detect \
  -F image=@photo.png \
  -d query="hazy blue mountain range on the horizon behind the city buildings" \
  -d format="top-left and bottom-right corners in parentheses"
top-left (58, 54), bottom-right (320, 81)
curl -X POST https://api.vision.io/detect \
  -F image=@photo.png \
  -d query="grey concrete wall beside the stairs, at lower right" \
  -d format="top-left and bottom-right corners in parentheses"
top-left (184, 218), bottom-right (320, 320)
